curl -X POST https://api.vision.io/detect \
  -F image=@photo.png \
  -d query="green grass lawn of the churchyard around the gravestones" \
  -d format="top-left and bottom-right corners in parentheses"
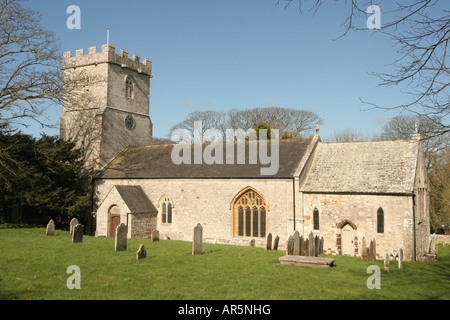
top-left (0, 228), bottom-right (450, 300)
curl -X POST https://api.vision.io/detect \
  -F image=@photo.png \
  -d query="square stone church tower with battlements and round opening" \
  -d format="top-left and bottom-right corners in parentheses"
top-left (60, 44), bottom-right (152, 173)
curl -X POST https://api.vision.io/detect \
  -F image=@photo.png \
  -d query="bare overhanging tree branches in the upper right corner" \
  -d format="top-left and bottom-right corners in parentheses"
top-left (284, 0), bottom-right (450, 138)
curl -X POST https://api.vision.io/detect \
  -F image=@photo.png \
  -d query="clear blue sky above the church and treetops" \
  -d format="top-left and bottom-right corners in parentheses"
top-left (23, 0), bottom-right (426, 137)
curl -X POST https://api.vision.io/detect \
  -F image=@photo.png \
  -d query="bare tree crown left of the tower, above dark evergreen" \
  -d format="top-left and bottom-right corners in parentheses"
top-left (0, 0), bottom-right (62, 126)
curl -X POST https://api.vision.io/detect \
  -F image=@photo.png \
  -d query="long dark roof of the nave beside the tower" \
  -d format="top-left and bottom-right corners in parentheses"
top-left (96, 138), bottom-right (313, 179)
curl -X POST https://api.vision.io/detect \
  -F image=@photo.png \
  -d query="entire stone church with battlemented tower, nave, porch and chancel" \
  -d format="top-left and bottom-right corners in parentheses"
top-left (61, 44), bottom-right (430, 261)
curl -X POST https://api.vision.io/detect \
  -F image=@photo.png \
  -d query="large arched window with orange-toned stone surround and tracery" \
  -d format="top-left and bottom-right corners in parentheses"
top-left (233, 189), bottom-right (267, 237)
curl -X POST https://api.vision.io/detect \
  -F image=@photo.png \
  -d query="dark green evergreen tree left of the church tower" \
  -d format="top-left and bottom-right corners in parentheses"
top-left (0, 130), bottom-right (91, 225)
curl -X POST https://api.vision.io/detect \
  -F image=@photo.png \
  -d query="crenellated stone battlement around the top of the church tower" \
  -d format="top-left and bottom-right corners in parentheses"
top-left (62, 44), bottom-right (152, 78)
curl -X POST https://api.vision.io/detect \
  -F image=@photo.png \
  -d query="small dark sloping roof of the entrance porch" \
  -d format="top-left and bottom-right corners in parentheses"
top-left (114, 186), bottom-right (158, 213)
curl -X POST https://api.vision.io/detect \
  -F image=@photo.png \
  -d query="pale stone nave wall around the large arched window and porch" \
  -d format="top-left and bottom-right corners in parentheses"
top-left (95, 179), bottom-right (293, 248)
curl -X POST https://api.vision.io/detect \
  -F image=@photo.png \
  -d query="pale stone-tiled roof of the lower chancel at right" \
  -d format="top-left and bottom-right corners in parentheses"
top-left (300, 140), bottom-right (419, 194)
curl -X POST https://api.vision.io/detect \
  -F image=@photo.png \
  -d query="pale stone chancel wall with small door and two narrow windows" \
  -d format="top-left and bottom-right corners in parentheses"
top-left (300, 193), bottom-right (414, 260)
